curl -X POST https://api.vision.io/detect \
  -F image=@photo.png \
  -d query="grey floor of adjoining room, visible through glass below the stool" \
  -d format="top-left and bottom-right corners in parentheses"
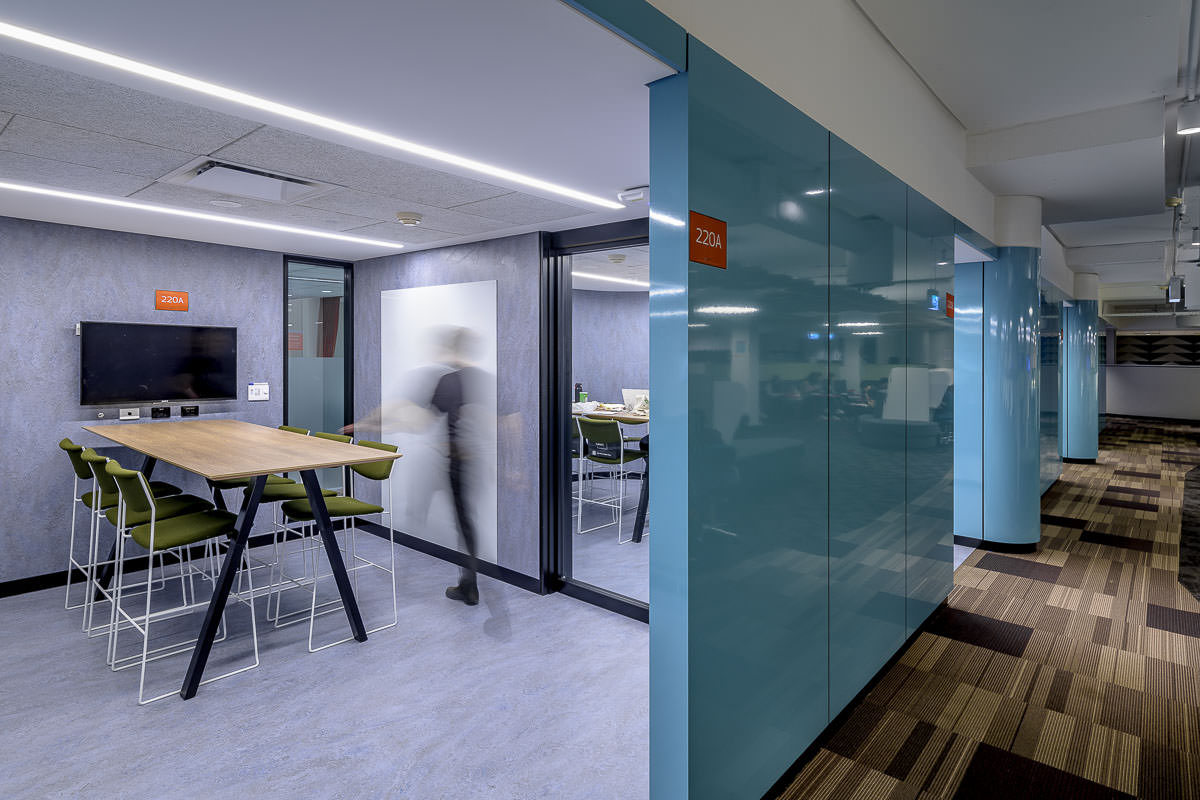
top-left (571, 477), bottom-right (650, 602)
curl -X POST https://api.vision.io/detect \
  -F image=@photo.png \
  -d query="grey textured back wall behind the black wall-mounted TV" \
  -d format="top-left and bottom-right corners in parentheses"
top-left (0, 217), bottom-right (283, 581)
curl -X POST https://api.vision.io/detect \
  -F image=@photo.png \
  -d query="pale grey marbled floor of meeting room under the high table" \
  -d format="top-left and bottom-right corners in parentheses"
top-left (0, 534), bottom-right (649, 800)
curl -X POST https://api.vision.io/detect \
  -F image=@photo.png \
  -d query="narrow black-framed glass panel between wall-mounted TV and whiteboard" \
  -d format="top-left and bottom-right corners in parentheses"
top-left (283, 259), bottom-right (354, 488)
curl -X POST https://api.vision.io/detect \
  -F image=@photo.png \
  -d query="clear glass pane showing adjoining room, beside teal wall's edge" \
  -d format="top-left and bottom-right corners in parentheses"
top-left (563, 245), bottom-right (650, 602)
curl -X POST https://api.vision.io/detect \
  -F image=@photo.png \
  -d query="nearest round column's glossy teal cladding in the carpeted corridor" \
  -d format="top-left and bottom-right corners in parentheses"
top-left (983, 247), bottom-right (1042, 546)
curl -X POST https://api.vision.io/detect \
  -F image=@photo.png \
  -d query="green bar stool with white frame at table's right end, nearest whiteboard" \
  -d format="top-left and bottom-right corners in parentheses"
top-left (281, 434), bottom-right (398, 652)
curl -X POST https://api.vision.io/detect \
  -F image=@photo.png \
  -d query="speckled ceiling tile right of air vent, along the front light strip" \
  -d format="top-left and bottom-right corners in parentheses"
top-left (215, 127), bottom-right (508, 209)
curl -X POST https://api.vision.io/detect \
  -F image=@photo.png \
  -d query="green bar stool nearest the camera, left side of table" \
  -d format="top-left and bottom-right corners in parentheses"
top-left (104, 461), bottom-right (258, 705)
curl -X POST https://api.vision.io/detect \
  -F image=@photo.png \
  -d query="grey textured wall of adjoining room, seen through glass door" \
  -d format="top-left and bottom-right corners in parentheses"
top-left (571, 290), bottom-right (650, 403)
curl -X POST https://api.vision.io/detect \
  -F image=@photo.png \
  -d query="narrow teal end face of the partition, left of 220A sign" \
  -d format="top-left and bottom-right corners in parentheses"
top-left (649, 74), bottom-right (690, 798)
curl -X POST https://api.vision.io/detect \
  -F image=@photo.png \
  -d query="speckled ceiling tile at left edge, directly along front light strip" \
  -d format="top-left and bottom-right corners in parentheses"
top-left (0, 54), bottom-right (259, 155)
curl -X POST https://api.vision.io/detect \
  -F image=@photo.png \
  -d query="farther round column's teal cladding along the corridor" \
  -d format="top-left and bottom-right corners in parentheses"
top-left (1062, 300), bottom-right (1100, 459)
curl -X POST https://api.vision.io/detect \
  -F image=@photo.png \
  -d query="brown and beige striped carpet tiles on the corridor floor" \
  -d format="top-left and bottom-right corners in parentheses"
top-left (779, 419), bottom-right (1200, 800)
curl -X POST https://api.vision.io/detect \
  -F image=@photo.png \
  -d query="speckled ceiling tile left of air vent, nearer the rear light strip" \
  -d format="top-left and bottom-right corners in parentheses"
top-left (0, 115), bottom-right (193, 178)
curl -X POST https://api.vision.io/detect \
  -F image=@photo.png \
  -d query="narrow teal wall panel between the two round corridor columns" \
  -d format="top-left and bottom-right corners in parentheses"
top-left (1038, 281), bottom-right (1066, 494)
